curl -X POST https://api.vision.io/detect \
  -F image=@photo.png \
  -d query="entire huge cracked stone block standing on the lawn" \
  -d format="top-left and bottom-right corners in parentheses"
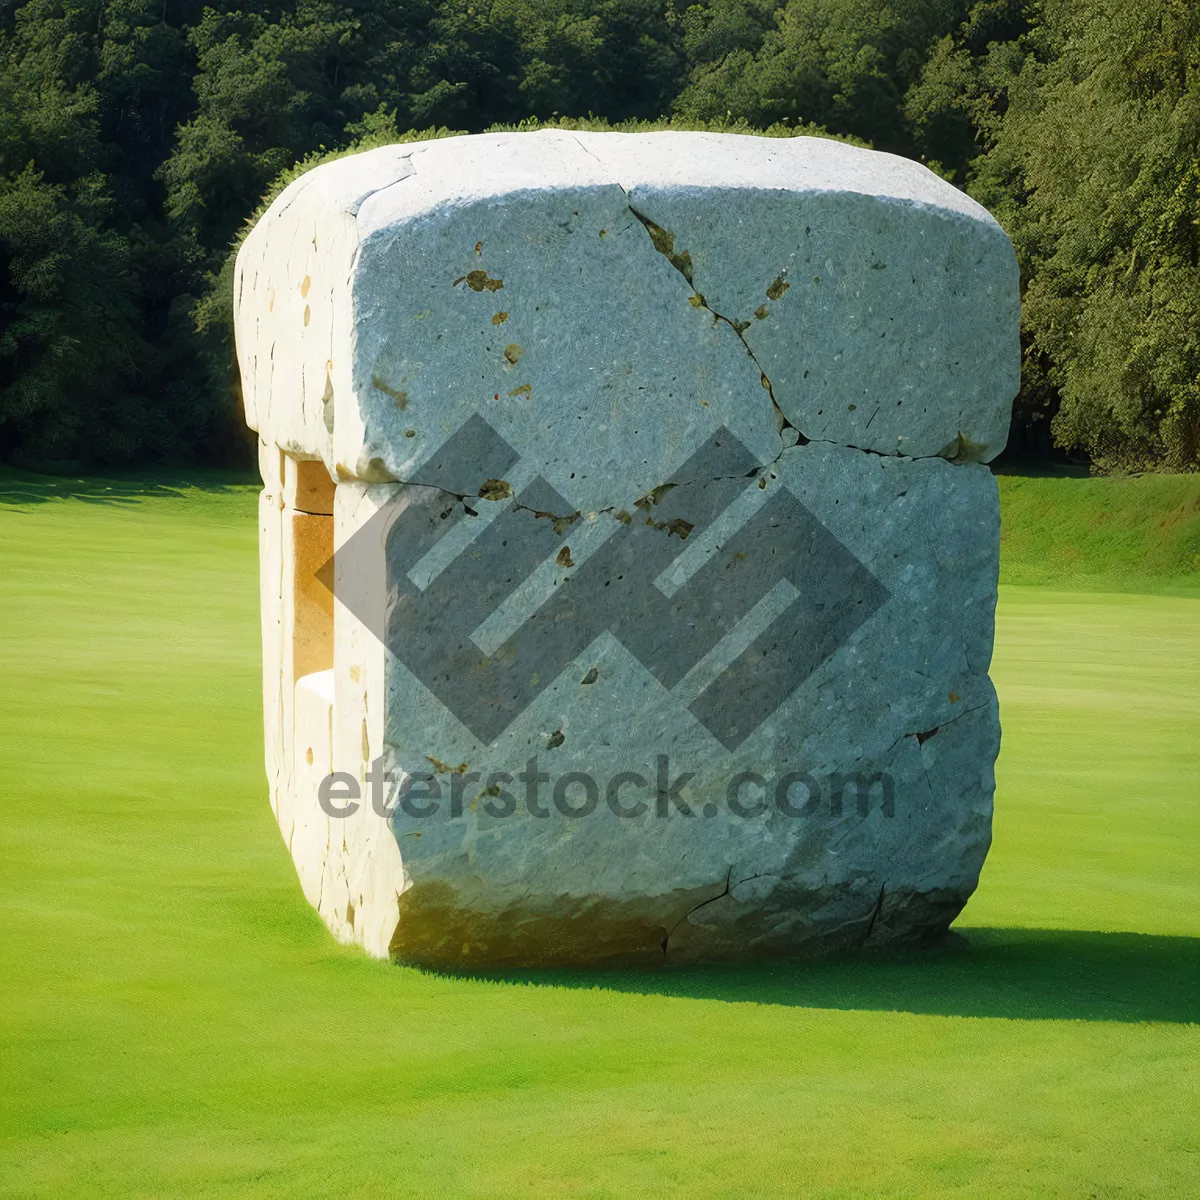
top-left (235, 132), bottom-right (1019, 964)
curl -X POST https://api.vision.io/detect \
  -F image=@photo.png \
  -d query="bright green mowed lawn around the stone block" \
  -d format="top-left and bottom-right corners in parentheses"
top-left (0, 476), bottom-right (1200, 1200)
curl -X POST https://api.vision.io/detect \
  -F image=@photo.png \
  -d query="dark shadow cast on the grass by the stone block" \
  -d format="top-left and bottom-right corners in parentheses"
top-left (444, 929), bottom-right (1200, 1024)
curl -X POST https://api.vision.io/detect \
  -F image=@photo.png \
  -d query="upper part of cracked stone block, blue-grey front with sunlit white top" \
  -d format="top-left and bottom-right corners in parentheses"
top-left (350, 133), bottom-right (1020, 487)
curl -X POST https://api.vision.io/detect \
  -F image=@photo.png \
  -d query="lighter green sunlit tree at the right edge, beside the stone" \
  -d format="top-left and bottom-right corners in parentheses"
top-left (971, 0), bottom-right (1200, 469)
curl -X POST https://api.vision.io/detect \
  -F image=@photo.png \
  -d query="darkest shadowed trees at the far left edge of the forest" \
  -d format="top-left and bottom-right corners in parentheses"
top-left (0, 0), bottom-right (213, 461)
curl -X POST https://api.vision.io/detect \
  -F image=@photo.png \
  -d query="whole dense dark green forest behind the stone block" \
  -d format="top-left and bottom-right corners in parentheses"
top-left (0, 0), bottom-right (1200, 470)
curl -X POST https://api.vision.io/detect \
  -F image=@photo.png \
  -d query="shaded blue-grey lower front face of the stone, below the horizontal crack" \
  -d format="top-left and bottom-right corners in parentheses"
top-left (385, 445), bottom-right (1000, 964)
